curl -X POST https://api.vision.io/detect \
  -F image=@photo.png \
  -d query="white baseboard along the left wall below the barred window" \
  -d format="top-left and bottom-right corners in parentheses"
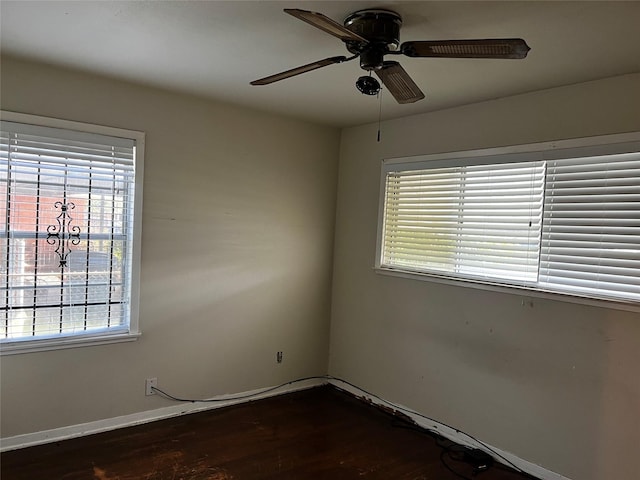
top-left (0, 377), bottom-right (327, 452)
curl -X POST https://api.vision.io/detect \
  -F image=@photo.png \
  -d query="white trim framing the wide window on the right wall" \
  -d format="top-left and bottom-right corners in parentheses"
top-left (373, 132), bottom-right (640, 312)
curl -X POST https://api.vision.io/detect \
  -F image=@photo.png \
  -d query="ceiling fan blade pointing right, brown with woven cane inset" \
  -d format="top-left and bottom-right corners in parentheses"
top-left (400, 38), bottom-right (531, 58)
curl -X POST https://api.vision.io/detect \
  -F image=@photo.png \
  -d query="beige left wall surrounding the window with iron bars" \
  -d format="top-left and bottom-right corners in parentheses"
top-left (1, 57), bottom-right (339, 437)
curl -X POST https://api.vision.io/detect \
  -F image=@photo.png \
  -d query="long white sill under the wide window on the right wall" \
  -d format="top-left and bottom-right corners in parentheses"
top-left (374, 266), bottom-right (640, 312)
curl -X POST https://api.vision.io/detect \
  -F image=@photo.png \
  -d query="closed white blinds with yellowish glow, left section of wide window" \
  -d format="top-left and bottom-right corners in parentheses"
top-left (381, 162), bottom-right (544, 282)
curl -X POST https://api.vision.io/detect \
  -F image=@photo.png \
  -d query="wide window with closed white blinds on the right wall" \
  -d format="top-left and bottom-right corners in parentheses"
top-left (376, 134), bottom-right (640, 306)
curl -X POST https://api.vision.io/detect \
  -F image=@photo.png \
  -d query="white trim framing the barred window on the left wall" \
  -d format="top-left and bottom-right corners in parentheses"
top-left (0, 110), bottom-right (146, 355)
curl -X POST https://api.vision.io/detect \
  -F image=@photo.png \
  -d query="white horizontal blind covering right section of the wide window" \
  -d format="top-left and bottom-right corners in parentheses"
top-left (540, 153), bottom-right (640, 301)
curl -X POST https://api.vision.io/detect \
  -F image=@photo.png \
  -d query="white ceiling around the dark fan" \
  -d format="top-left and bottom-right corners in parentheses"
top-left (0, 0), bottom-right (640, 126)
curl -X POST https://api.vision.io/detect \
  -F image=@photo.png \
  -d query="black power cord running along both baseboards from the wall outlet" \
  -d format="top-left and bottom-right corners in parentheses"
top-left (151, 375), bottom-right (537, 480)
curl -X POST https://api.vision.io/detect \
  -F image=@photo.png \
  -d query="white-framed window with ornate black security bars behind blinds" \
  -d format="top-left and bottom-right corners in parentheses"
top-left (0, 112), bottom-right (144, 353)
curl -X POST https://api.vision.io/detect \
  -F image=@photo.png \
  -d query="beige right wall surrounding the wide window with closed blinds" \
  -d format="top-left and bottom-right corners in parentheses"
top-left (329, 74), bottom-right (640, 480)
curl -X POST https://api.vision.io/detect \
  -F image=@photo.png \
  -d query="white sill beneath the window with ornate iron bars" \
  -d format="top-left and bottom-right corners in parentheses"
top-left (0, 332), bottom-right (140, 355)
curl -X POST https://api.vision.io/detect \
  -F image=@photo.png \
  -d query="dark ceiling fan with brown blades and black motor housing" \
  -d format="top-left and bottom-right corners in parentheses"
top-left (251, 8), bottom-right (530, 103)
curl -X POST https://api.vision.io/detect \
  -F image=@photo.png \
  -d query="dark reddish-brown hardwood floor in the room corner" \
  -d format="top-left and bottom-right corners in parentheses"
top-left (0, 386), bottom-right (532, 480)
